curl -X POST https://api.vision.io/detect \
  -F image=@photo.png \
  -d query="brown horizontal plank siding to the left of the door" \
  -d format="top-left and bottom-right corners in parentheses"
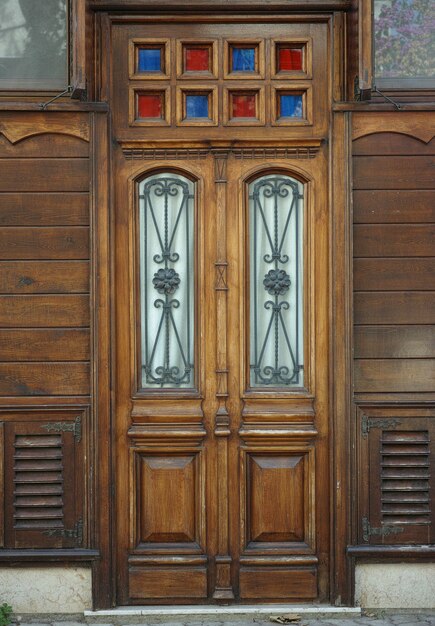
top-left (0, 120), bottom-right (91, 396)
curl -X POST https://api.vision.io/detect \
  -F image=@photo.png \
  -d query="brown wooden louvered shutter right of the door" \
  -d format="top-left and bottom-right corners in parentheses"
top-left (360, 409), bottom-right (435, 545)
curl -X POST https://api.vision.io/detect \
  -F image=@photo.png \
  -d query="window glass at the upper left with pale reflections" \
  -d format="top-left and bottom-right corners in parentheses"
top-left (0, 0), bottom-right (68, 89)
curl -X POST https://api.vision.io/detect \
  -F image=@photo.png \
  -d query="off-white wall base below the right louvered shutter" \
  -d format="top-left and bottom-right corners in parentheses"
top-left (355, 563), bottom-right (435, 609)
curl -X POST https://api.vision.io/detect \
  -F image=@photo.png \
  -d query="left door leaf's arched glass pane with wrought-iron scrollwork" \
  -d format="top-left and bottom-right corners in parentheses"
top-left (139, 173), bottom-right (195, 389)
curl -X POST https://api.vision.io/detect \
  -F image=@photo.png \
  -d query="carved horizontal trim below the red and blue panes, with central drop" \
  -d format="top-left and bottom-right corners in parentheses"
top-left (122, 144), bottom-right (320, 158)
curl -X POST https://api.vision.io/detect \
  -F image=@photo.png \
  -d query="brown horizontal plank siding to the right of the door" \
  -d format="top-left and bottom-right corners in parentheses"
top-left (353, 129), bottom-right (435, 394)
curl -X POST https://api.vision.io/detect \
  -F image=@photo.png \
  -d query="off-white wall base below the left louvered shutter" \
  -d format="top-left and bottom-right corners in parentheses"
top-left (0, 567), bottom-right (92, 614)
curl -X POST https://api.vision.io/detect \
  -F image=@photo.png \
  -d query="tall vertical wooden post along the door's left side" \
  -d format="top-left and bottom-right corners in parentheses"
top-left (89, 109), bottom-right (113, 609)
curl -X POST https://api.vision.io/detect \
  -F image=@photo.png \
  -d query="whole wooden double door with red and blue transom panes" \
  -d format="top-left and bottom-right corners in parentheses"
top-left (109, 17), bottom-right (330, 604)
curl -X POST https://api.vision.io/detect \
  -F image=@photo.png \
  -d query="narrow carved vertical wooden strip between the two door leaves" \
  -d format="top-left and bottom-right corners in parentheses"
top-left (213, 151), bottom-right (234, 600)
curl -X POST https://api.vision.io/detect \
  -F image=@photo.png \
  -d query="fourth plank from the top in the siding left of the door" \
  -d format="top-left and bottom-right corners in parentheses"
top-left (0, 226), bottom-right (89, 260)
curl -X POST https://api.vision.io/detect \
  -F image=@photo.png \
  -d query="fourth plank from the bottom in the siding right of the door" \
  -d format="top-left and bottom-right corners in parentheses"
top-left (353, 256), bottom-right (435, 291)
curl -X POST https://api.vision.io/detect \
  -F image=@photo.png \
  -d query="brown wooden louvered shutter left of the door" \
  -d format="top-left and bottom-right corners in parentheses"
top-left (4, 412), bottom-right (84, 549)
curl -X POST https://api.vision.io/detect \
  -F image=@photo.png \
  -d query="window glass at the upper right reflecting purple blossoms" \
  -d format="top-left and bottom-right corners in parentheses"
top-left (374, 0), bottom-right (435, 87)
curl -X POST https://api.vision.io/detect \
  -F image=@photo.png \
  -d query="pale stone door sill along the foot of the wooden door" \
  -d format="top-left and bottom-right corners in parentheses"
top-left (84, 604), bottom-right (361, 621)
